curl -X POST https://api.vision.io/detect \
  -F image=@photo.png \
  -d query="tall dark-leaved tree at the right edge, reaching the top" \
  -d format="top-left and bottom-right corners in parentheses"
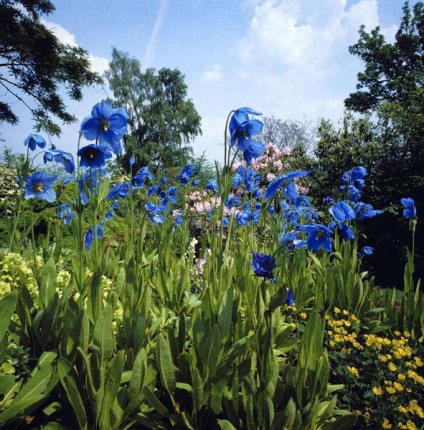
top-left (345, 2), bottom-right (424, 191)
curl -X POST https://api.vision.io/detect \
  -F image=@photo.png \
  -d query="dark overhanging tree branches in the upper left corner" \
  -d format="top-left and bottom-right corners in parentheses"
top-left (0, 0), bottom-right (101, 135)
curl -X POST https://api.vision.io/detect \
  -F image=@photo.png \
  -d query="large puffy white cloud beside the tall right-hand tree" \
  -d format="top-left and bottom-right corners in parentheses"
top-left (238, 0), bottom-right (385, 122)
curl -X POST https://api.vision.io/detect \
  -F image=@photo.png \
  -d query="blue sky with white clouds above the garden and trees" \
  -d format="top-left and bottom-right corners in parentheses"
top-left (1, 0), bottom-right (416, 161)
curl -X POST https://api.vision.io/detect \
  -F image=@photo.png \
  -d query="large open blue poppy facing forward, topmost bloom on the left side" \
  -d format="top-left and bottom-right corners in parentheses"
top-left (81, 101), bottom-right (128, 155)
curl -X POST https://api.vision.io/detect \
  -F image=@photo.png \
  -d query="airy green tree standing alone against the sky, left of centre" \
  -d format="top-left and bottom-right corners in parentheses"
top-left (105, 48), bottom-right (201, 173)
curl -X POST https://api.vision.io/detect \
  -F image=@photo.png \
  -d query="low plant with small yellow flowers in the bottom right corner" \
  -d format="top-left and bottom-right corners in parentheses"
top-left (325, 308), bottom-right (424, 429)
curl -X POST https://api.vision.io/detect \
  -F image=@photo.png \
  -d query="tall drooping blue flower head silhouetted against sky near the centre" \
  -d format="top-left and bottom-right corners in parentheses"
top-left (229, 107), bottom-right (265, 165)
